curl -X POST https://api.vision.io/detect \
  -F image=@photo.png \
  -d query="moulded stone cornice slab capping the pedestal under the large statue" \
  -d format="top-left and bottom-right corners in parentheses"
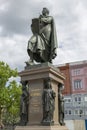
top-left (19, 62), bottom-right (65, 84)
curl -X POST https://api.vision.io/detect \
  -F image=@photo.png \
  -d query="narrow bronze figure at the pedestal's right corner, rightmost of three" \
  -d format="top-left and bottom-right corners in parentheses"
top-left (58, 83), bottom-right (65, 125)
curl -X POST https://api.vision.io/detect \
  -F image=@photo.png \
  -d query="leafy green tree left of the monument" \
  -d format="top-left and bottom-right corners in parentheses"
top-left (0, 62), bottom-right (21, 125)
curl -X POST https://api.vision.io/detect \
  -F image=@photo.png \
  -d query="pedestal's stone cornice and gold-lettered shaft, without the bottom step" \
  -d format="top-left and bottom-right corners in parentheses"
top-left (19, 63), bottom-right (65, 126)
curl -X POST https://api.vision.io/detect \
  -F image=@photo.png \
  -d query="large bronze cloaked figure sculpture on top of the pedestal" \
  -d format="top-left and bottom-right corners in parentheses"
top-left (27, 8), bottom-right (57, 65)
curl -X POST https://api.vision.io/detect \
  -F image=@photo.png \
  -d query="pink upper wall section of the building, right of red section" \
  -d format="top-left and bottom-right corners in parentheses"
top-left (69, 61), bottom-right (87, 94)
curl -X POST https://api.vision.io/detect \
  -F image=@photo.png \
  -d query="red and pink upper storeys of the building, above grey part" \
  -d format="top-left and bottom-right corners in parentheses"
top-left (58, 61), bottom-right (87, 95)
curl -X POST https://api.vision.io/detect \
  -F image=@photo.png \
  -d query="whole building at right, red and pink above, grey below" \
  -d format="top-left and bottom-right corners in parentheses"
top-left (58, 61), bottom-right (87, 120)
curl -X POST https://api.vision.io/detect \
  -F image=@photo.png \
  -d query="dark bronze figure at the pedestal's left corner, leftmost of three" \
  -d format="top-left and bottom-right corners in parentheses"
top-left (20, 81), bottom-right (29, 126)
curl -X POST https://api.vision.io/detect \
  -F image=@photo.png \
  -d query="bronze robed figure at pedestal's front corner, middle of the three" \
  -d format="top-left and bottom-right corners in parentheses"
top-left (42, 79), bottom-right (56, 125)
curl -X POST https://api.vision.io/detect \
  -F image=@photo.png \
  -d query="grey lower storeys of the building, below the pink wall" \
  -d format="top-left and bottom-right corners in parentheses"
top-left (64, 94), bottom-right (87, 120)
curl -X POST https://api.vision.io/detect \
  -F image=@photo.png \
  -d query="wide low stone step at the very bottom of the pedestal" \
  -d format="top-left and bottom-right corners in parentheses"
top-left (15, 125), bottom-right (68, 130)
